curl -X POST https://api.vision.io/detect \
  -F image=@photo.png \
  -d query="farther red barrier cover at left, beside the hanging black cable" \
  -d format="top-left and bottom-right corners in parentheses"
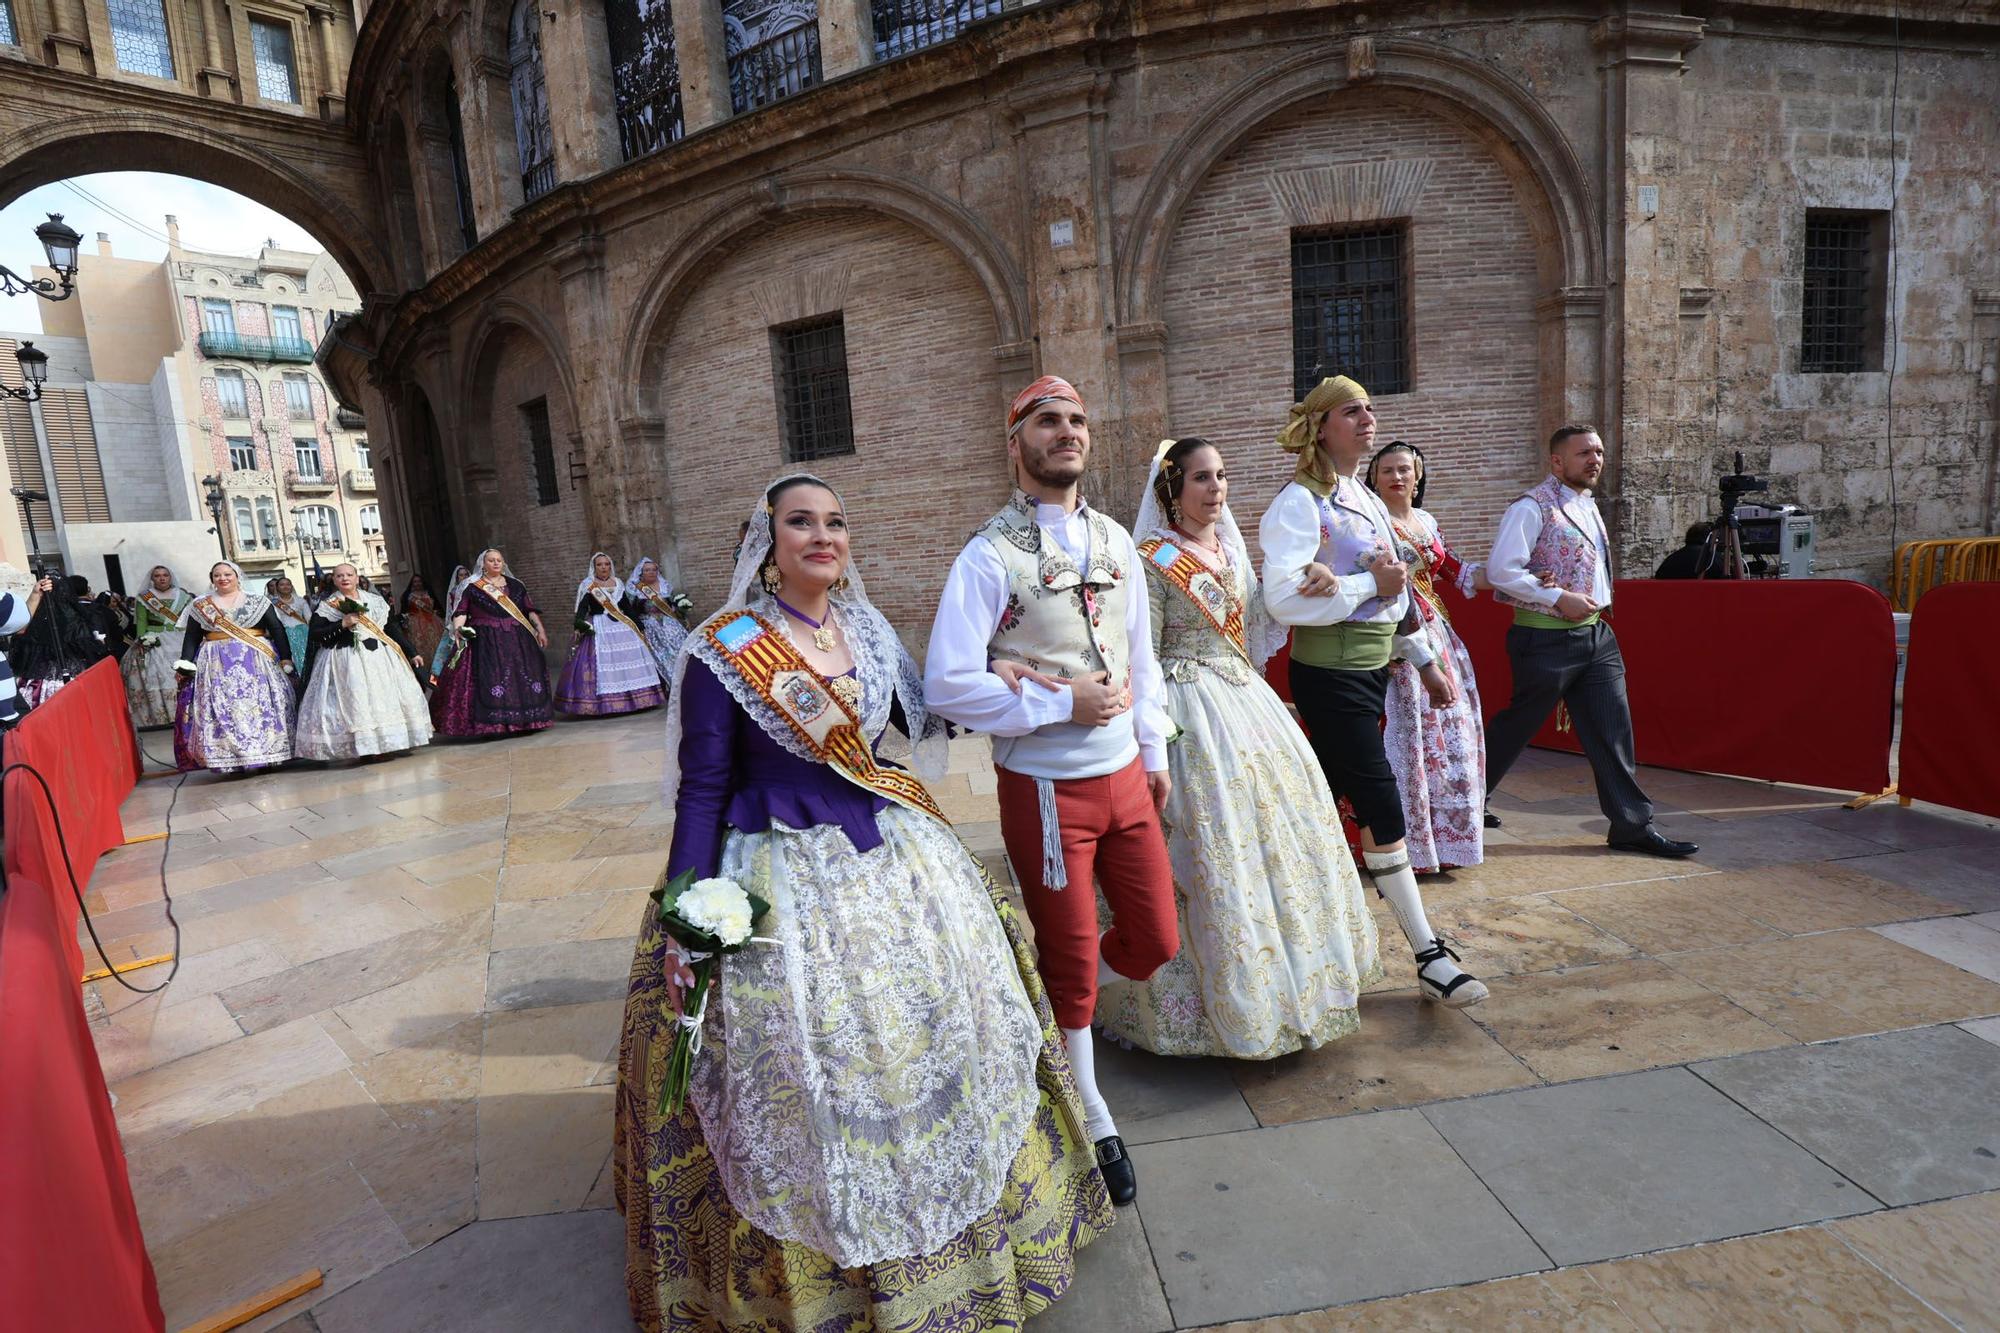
top-left (4, 658), bottom-right (140, 981)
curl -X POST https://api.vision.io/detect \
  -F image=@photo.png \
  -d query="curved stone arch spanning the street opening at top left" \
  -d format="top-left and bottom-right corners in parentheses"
top-left (0, 112), bottom-right (402, 292)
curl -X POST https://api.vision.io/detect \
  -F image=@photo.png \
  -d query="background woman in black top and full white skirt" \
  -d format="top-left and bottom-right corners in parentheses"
top-left (292, 564), bottom-right (430, 759)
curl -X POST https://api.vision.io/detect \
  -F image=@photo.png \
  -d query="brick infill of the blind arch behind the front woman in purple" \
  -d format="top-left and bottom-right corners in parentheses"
top-left (652, 212), bottom-right (1008, 644)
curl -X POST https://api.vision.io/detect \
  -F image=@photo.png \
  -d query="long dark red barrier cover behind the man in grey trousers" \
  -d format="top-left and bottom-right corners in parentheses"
top-left (1270, 578), bottom-right (1896, 791)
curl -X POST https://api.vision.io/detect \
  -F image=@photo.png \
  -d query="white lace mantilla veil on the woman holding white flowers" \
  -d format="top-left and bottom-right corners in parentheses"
top-left (660, 472), bottom-right (948, 805)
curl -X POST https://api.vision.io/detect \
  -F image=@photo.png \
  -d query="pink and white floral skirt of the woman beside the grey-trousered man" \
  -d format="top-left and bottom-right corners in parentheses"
top-left (1382, 620), bottom-right (1486, 875)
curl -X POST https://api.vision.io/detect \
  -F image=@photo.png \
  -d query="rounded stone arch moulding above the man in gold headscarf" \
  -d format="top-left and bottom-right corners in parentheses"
top-left (1118, 38), bottom-right (1604, 324)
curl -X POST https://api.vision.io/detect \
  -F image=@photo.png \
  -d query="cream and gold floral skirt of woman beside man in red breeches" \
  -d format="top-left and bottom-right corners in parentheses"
top-left (1098, 662), bottom-right (1382, 1061)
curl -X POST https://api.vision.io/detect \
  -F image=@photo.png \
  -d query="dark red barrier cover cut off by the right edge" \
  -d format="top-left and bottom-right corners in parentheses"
top-left (1896, 582), bottom-right (2000, 817)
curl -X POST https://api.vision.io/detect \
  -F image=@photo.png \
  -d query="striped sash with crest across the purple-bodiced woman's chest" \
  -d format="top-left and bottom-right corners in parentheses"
top-left (702, 610), bottom-right (950, 827)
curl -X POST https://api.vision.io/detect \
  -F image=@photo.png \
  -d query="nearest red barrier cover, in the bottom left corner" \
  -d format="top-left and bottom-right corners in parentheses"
top-left (0, 868), bottom-right (166, 1333)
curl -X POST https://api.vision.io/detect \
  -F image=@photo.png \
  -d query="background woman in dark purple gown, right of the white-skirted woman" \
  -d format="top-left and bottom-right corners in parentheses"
top-left (430, 548), bottom-right (550, 737)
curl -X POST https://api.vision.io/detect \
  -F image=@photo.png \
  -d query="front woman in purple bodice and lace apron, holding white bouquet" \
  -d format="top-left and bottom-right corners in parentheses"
top-left (612, 476), bottom-right (1112, 1333)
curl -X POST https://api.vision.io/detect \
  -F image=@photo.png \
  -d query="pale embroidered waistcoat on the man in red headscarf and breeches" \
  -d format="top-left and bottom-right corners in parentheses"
top-left (978, 490), bottom-right (1130, 685)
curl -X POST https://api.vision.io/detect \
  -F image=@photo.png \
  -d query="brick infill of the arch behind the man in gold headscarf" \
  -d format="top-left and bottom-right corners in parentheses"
top-left (1168, 87), bottom-right (1540, 556)
